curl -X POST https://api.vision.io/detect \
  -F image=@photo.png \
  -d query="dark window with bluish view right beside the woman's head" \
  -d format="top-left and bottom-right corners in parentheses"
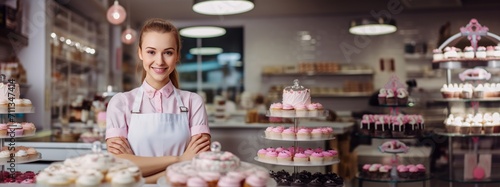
top-left (177, 27), bottom-right (244, 103)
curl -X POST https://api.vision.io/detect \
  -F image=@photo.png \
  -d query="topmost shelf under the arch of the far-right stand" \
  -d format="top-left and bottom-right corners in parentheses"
top-left (432, 58), bottom-right (500, 69)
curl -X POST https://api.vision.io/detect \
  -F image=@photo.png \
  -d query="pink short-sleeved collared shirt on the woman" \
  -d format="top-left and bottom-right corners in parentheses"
top-left (106, 81), bottom-right (210, 139)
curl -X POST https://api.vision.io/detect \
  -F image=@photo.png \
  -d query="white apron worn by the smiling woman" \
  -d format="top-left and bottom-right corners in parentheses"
top-left (128, 87), bottom-right (191, 157)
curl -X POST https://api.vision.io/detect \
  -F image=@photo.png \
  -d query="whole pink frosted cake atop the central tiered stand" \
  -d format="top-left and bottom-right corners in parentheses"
top-left (282, 79), bottom-right (311, 107)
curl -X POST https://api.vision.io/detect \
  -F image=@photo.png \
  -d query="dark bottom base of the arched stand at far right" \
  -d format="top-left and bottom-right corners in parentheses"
top-left (434, 172), bottom-right (500, 184)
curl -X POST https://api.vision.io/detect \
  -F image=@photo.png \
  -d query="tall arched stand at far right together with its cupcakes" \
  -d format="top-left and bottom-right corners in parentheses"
top-left (432, 19), bottom-right (500, 186)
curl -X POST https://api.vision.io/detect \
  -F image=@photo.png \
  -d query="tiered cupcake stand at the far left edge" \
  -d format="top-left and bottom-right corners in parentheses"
top-left (0, 96), bottom-right (42, 181)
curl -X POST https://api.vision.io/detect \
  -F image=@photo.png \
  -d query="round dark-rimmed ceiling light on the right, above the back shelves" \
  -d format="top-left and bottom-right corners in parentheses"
top-left (349, 18), bottom-right (397, 35)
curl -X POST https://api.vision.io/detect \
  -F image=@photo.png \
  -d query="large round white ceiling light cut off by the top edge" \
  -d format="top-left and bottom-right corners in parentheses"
top-left (193, 0), bottom-right (255, 15)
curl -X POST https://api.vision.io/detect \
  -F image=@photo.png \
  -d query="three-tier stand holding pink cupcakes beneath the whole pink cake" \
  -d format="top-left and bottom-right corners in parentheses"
top-left (254, 110), bottom-right (340, 173)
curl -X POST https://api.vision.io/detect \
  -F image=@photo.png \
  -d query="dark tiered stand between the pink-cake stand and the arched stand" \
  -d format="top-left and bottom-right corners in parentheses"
top-left (356, 76), bottom-right (431, 187)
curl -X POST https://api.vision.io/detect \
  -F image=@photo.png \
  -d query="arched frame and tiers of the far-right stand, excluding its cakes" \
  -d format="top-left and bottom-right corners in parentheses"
top-left (432, 19), bottom-right (500, 187)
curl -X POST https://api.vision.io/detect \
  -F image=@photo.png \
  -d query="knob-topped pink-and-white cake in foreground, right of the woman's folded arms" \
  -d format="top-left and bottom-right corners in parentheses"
top-left (191, 142), bottom-right (240, 173)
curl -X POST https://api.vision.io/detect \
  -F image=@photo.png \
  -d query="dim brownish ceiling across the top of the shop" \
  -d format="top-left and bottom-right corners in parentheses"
top-left (57, 0), bottom-right (500, 25)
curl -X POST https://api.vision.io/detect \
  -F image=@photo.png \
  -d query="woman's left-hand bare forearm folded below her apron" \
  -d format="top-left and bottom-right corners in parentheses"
top-left (115, 154), bottom-right (180, 177)
